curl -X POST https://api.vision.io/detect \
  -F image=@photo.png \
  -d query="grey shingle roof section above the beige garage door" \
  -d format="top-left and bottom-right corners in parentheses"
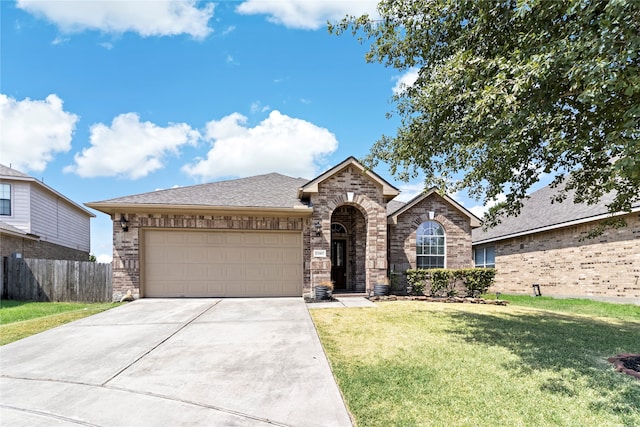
top-left (95, 173), bottom-right (307, 208)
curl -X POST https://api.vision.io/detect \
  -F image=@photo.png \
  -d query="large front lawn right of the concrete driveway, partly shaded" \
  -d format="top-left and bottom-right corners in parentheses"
top-left (311, 301), bottom-right (640, 426)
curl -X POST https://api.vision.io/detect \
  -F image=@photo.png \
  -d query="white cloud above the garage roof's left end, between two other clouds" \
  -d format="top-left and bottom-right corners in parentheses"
top-left (64, 113), bottom-right (200, 179)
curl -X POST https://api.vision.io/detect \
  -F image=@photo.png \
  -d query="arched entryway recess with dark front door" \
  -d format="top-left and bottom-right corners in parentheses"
top-left (330, 204), bottom-right (367, 292)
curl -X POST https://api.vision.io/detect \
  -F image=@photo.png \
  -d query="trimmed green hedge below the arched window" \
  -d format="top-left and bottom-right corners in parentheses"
top-left (406, 268), bottom-right (496, 296)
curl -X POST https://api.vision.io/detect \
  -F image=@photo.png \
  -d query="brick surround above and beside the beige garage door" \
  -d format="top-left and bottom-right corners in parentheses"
top-left (112, 213), bottom-right (309, 300)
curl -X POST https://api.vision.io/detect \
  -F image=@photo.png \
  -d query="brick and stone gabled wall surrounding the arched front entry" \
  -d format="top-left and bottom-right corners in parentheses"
top-left (305, 166), bottom-right (387, 293)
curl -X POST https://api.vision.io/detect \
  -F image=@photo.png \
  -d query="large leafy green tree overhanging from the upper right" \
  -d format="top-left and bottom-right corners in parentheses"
top-left (329, 0), bottom-right (640, 224)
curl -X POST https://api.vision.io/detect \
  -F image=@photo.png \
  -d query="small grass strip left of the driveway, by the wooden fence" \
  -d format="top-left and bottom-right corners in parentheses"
top-left (0, 300), bottom-right (120, 345)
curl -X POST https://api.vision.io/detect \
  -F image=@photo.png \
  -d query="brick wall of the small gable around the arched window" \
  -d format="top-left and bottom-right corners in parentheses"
top-left (389, 193), bottom-right (473, 285)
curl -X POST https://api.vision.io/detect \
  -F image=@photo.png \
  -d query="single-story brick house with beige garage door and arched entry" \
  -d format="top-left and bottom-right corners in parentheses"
top-left (86, 157), bottom-right (480, 298)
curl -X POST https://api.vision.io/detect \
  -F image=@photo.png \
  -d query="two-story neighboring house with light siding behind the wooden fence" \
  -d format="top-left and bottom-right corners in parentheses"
top-left (0, 165), bottom-right (95, 261)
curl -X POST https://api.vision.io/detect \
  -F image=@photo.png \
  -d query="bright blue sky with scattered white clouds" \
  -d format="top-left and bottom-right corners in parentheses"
top-left (0, 0), bottom-right (504, 262)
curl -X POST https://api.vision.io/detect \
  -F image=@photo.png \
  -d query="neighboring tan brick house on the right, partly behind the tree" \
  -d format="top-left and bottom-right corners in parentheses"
top-left (473, 182), bottom-right (640, 302)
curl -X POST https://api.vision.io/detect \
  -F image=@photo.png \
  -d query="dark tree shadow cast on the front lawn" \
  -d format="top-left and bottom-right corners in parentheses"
top-left (448, 312), bottom-right (640, 421)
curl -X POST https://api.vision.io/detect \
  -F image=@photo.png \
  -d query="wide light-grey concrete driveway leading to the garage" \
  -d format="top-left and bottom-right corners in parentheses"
top-left (0, 298), bottom-right (351, 427)
